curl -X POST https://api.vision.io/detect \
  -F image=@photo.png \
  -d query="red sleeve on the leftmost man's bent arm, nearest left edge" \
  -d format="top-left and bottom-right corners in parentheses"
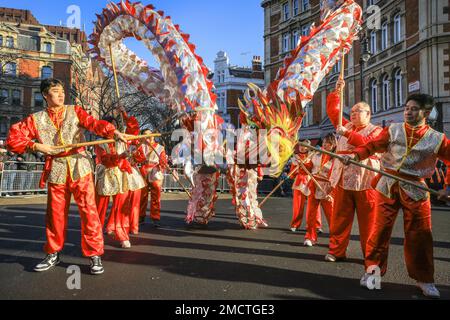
top-left (6, 116), bottom-right (38, 154)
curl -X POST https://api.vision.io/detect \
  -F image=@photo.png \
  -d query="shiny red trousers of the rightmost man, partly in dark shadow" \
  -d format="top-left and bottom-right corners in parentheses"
top-left (365, 184), bottom-right (434, 283)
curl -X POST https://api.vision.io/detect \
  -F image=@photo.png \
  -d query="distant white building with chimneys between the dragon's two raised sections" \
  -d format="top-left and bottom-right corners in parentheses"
top-left (213, 51), bottom-right (265, 128)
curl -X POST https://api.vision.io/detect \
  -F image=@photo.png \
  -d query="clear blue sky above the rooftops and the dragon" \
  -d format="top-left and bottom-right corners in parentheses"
top-left (0, 0), bottom-right (264, 69)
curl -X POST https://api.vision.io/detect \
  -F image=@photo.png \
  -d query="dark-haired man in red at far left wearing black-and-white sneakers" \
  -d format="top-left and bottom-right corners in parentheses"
top-left (7, 79), bottom-right (125, 274)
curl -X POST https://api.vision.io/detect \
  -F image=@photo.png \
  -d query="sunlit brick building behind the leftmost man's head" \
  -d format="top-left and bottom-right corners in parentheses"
top-left (0, 8), bottom-right (103, 139)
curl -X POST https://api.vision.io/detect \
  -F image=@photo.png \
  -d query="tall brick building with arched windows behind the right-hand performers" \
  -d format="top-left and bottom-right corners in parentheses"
top-left (261, 0), bottom-right (450, 139)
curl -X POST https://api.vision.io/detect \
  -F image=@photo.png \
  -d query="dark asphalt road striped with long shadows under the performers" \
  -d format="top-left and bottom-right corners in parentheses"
top-left (0, 194), bottom-right (450, 300)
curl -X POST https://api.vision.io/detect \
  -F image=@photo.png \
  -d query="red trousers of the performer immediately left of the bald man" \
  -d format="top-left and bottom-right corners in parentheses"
top-left (305, 186), bottom-right (334, 242)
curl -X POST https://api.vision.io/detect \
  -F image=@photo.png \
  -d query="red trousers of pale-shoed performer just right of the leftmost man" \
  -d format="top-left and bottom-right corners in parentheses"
top-left (106, 192), bottom-right (131, 241)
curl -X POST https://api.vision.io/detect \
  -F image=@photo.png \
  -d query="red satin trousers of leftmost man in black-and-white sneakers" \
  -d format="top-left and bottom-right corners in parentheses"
top-left (44, 174), bottom-right (103, 257)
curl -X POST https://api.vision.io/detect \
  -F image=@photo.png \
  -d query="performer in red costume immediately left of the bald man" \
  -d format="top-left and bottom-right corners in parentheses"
top-left (304, 134), bottom-right (336, 247)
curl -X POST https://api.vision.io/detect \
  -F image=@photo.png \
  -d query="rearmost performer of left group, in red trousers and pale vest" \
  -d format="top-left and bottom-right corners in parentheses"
top-left (139, 130), bottom-right (167, 227)
